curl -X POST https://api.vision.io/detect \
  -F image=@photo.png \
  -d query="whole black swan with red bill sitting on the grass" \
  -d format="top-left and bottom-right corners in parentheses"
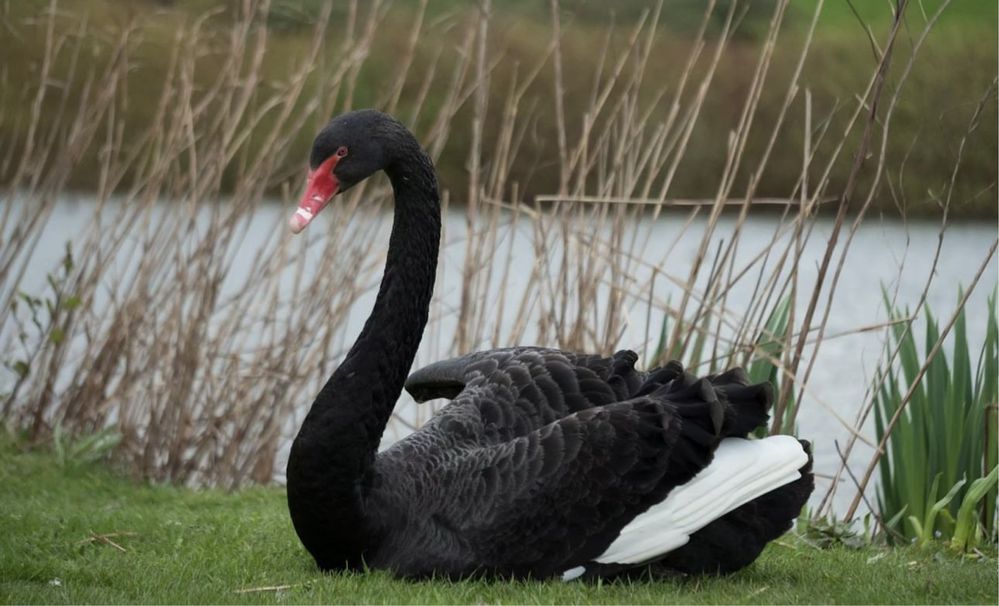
top-left (287, 110), bottom-right (813, 580)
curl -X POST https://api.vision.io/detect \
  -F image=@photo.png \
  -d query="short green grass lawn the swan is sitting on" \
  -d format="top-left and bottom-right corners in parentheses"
top-left (0, 443), bottom-right (997, 604)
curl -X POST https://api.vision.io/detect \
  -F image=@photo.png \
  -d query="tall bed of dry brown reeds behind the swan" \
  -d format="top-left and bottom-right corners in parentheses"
top-left (0, 0), bottom-right (994, 540)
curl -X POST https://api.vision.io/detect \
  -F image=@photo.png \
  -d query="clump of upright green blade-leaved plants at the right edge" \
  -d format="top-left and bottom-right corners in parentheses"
top-left (874, 292), bottom-right (999, 549)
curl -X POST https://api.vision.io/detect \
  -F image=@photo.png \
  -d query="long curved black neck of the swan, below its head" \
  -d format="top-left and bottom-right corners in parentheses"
top-left (287, 141), bottom-right (441, 568)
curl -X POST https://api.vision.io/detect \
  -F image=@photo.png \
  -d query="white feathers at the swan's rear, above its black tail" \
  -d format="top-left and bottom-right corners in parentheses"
top-left (584, 436), bottom-right (811, 572)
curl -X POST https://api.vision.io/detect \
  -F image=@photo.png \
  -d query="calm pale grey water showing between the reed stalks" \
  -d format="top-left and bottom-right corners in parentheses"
top-left (9, 199), bottom-right (997, 508)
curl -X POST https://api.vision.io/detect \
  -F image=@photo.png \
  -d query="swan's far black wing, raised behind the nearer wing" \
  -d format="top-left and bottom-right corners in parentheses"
top-left (406, 347), bottom-right (773, 446)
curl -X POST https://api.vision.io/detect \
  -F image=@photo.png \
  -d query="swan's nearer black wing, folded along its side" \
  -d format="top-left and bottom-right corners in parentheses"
top-left (379, 376), bottom-right (723, 576)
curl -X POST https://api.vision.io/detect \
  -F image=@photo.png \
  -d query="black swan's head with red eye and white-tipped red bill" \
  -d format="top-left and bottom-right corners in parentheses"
top-left (289, 109), bottom-right (398, 234)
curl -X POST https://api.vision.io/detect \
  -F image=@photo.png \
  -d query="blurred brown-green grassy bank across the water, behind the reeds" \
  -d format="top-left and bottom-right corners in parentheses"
top-left (0, 0), bottom-right (997, 218)
